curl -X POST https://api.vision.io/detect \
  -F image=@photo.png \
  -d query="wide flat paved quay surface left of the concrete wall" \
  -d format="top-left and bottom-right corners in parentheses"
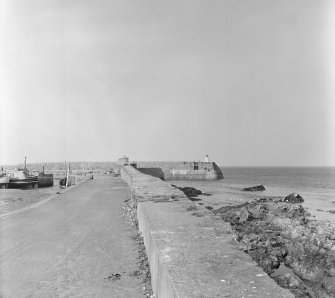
top-left (0, 177), bottom-right (143, 297)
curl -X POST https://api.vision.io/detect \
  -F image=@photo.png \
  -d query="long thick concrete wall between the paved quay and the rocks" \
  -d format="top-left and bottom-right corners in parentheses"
top-left (120, 166), bottom-right (294, 298)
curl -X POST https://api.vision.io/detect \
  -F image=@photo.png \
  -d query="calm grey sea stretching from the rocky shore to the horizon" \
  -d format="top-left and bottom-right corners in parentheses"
top-left (170, 167), bottom-right (335, 221)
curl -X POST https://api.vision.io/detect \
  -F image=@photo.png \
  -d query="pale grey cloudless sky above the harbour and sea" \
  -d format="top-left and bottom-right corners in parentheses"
top-left (0, 0), bottom-right (335, 166)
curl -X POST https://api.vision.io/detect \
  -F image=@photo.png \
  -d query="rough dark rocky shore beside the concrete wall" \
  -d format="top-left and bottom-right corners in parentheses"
top-left (212, 198), bottom-right (335, 298)
